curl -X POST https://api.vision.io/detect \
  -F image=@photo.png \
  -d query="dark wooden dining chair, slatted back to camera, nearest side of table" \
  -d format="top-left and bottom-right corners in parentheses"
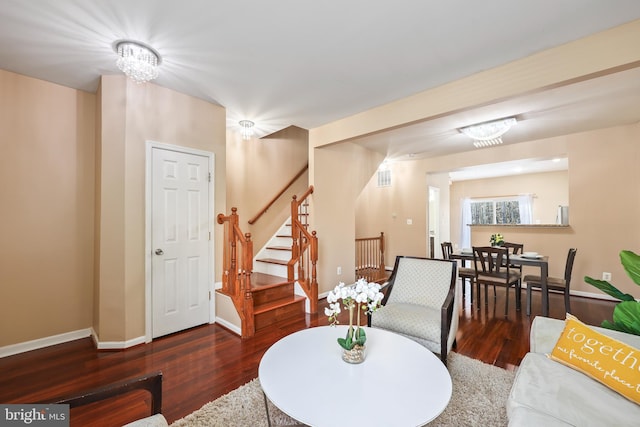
top-left (473, 246), bottom-right (522, 316)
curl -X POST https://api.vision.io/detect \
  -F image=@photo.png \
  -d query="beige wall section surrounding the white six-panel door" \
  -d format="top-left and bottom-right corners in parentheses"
top-left (96, 75), bottom-right (226, 342)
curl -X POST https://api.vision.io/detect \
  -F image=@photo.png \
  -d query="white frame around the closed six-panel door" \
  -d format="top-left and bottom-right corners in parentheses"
top-left (144, 141), bottom-right (216, 342)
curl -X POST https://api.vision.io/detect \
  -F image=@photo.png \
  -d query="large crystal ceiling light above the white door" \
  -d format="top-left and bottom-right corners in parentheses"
top-left (113, 40), bottom-right (162, 83)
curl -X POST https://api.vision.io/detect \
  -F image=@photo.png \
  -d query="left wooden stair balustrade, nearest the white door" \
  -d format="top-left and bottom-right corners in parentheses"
top-left (218, 208), bottom-right (255, 338)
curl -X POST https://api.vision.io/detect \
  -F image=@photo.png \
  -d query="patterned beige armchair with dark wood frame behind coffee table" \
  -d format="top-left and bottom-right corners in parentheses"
top-left (368, 256), bottom-right (459, 365)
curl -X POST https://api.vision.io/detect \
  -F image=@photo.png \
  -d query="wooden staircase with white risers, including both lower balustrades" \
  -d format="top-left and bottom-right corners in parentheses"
top-left (217, 186), bottom-right (318, 338)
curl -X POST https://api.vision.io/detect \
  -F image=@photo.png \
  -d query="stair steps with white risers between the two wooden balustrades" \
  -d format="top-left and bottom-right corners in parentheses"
top-left (251, 221), bottom-right (307, 331)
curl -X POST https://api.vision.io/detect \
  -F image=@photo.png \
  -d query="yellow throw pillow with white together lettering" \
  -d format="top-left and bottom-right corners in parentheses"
top-left (549, 314), bottom-right (640, 404)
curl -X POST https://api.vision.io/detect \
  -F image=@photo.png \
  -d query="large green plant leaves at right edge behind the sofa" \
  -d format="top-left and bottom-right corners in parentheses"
top-left (584, 250), bottom-right (640, 335)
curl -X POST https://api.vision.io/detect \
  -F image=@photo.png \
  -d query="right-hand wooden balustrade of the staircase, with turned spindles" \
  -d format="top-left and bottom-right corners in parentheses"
top-left (287, 185), bottom-right (318, 313)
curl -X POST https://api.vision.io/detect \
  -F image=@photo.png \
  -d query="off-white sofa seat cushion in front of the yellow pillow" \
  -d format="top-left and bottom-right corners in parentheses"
top-left (507, 353), bottom-right (640, 427)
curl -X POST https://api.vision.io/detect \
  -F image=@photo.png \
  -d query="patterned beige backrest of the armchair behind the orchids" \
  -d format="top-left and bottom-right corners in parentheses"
top-left (386, 256), bottom-right (457, 308)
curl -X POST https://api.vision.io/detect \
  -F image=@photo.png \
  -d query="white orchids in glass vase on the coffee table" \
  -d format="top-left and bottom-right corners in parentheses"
top-left (324, 278), bottom-right (384, 363)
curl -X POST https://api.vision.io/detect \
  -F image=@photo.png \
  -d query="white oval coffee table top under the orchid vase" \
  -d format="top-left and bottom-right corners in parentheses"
top-left (258, 326), bottom-right (451, 427)
